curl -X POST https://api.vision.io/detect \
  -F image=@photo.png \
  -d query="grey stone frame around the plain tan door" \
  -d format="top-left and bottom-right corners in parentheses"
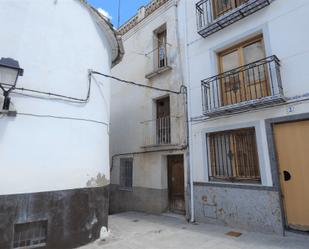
top-left (265, 113), bottom-right (309, 235)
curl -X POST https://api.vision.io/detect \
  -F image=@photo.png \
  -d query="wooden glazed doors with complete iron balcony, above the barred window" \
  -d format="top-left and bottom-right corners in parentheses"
top-left (202, 35), bottom-right (286, 116)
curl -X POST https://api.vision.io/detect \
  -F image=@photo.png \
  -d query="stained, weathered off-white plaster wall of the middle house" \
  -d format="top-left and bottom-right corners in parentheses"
top-left (110, 1), bottom-right (186, 189)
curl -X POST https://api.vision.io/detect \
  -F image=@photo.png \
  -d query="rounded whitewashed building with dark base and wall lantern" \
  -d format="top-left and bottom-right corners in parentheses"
top-left (0, 0), bottom-right (123, 249)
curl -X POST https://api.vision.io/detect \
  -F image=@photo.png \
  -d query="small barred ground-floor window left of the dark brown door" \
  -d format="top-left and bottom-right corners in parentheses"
top-left (120, 158), bottom-right (133, 190)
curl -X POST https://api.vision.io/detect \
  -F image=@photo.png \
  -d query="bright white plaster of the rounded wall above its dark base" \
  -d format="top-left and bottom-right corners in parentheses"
top-left (0, 0), bottom-right (111, 195)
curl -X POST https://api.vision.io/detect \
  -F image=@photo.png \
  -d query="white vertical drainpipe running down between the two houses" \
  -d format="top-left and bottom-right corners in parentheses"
top-left (183, 1), bottom-right (195, 223)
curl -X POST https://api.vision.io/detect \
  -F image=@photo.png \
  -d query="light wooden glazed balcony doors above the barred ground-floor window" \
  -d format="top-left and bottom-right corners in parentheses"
top-left (218, 36), bottom-right (271, 105)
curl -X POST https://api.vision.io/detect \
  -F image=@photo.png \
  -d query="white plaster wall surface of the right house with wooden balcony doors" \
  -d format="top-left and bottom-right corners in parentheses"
top-left (180, 0), bottom-right (309, 186)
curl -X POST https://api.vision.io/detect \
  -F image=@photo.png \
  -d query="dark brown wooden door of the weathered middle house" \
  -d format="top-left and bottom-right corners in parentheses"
top-left (168, 155), bottom-right (185, 213)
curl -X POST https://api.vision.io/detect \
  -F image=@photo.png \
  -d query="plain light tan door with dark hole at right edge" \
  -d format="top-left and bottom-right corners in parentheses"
top-left (274, 121), bottom-right (309, 231)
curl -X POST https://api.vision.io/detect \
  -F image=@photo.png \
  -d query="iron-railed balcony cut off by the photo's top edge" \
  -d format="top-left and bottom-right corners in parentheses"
top-left (196, 0), bottom-right (273, 38)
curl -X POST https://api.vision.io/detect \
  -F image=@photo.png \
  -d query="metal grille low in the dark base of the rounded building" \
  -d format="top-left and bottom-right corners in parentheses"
top-left (13, 221), bottom-right (47, 249)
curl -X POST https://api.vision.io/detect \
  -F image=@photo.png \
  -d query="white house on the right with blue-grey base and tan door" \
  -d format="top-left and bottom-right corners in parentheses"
top-left (180, 0), bottom-right (309, 234)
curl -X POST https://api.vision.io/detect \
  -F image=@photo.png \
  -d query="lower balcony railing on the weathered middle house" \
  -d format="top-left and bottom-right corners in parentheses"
top-left (141, 116), bottom-right (182, 149)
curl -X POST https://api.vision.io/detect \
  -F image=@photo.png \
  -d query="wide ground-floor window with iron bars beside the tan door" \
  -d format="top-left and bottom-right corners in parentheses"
top-left (207, 128), bottom-right (261, 183)
